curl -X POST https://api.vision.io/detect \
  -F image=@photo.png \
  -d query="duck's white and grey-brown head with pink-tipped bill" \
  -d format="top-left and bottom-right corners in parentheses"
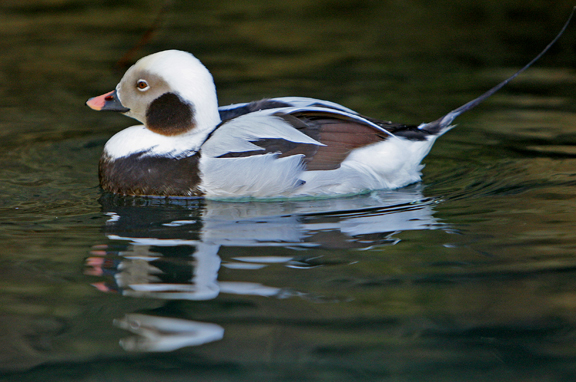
top-left (86, 50), bottom-right (220, 136)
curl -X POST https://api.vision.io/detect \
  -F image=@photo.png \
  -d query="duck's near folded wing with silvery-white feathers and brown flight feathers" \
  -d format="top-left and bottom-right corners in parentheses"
top-left (202, 107), bottom-right (420, 171)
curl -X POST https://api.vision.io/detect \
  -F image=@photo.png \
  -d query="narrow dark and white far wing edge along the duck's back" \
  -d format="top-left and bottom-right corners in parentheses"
top-left (218, 97), bottom-right (358, 121)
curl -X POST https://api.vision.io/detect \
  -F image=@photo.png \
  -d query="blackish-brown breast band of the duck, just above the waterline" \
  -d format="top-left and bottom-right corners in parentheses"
top-left (98, 153), bottom-right (202, 196)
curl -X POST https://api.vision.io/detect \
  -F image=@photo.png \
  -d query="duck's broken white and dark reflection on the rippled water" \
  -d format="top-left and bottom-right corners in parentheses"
top-left (85, 185), bottom-right (446, 351)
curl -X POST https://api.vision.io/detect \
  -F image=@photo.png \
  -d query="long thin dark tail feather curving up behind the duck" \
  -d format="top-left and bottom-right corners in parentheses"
top-left (419, 7), bottom-right (576, 135)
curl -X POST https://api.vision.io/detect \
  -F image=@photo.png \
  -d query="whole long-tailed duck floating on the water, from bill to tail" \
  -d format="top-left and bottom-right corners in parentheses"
top-left (87, 15), bottom-right (572, 198)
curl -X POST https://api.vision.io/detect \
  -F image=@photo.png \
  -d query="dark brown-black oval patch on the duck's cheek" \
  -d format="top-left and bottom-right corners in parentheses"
top-left (146, 93), bottom-right (195, 135)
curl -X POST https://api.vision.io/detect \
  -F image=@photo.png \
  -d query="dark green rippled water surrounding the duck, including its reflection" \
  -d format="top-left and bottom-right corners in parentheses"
top-left (0, 0), bottom-right (576, 381)
